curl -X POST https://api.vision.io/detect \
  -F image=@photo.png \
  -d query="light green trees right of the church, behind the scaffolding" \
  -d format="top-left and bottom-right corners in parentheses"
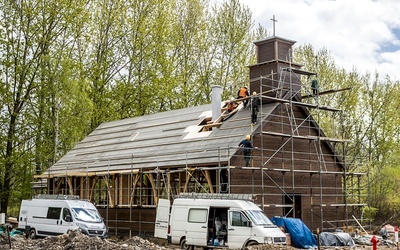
top-left (296, 45), bottom-right (400, 221)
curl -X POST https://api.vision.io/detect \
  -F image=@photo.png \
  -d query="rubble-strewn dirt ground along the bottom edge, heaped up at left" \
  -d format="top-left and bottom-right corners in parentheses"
top-left (0, 231), bottom-right (396, 250)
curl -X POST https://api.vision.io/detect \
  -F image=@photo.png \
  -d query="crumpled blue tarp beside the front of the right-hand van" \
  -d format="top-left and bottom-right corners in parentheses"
top-left (271, 217), bottom-right (317, 248)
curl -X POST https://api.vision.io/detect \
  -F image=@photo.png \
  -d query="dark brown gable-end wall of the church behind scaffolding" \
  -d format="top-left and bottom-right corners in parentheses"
top-left (230, 104), bottom-right (344, 229)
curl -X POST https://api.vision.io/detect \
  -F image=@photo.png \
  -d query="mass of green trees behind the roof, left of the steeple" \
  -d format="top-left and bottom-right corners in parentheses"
top-left (0, 0), bottom-right (252, 212)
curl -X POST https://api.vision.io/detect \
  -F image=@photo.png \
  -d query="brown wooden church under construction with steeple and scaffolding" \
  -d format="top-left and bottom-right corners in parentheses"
top-left (35, 36), bottom-right (365, 235)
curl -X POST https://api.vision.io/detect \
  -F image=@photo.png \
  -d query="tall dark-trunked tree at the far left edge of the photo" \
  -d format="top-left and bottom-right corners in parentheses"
top-left (0, 0), bottom-right (89, 213)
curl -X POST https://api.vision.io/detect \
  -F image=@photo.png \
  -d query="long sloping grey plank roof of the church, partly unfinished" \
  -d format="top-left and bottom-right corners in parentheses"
top-left (40, 101), bottom-right (278, 177)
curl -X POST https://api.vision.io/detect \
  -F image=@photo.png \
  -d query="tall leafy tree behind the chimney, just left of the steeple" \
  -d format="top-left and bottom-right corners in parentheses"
top-left (203, 0), bottom-right (253, 99)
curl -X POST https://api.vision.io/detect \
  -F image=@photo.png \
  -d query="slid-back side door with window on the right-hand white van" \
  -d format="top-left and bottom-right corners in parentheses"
top-left (186, 208), bottom-right (208, 246)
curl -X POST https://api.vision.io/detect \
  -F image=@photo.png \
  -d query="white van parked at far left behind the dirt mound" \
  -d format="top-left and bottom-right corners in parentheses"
top-left (18, 195), bottom-right (108, 239)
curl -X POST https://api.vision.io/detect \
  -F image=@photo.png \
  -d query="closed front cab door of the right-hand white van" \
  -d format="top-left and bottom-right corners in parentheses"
top-left (227, 209), bottom-right (251, 248)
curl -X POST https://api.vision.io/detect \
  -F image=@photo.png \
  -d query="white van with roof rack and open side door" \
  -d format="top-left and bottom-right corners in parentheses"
top-left (154, 193), bottom-right (286, 249)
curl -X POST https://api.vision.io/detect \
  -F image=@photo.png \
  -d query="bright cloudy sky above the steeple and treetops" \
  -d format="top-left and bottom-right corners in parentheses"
top-left (234, 0), bottom-right (400, 80)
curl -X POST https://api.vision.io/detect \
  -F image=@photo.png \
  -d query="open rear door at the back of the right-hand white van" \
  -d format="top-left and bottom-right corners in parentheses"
top-left (154, 199), bottom-right (171, 239)
